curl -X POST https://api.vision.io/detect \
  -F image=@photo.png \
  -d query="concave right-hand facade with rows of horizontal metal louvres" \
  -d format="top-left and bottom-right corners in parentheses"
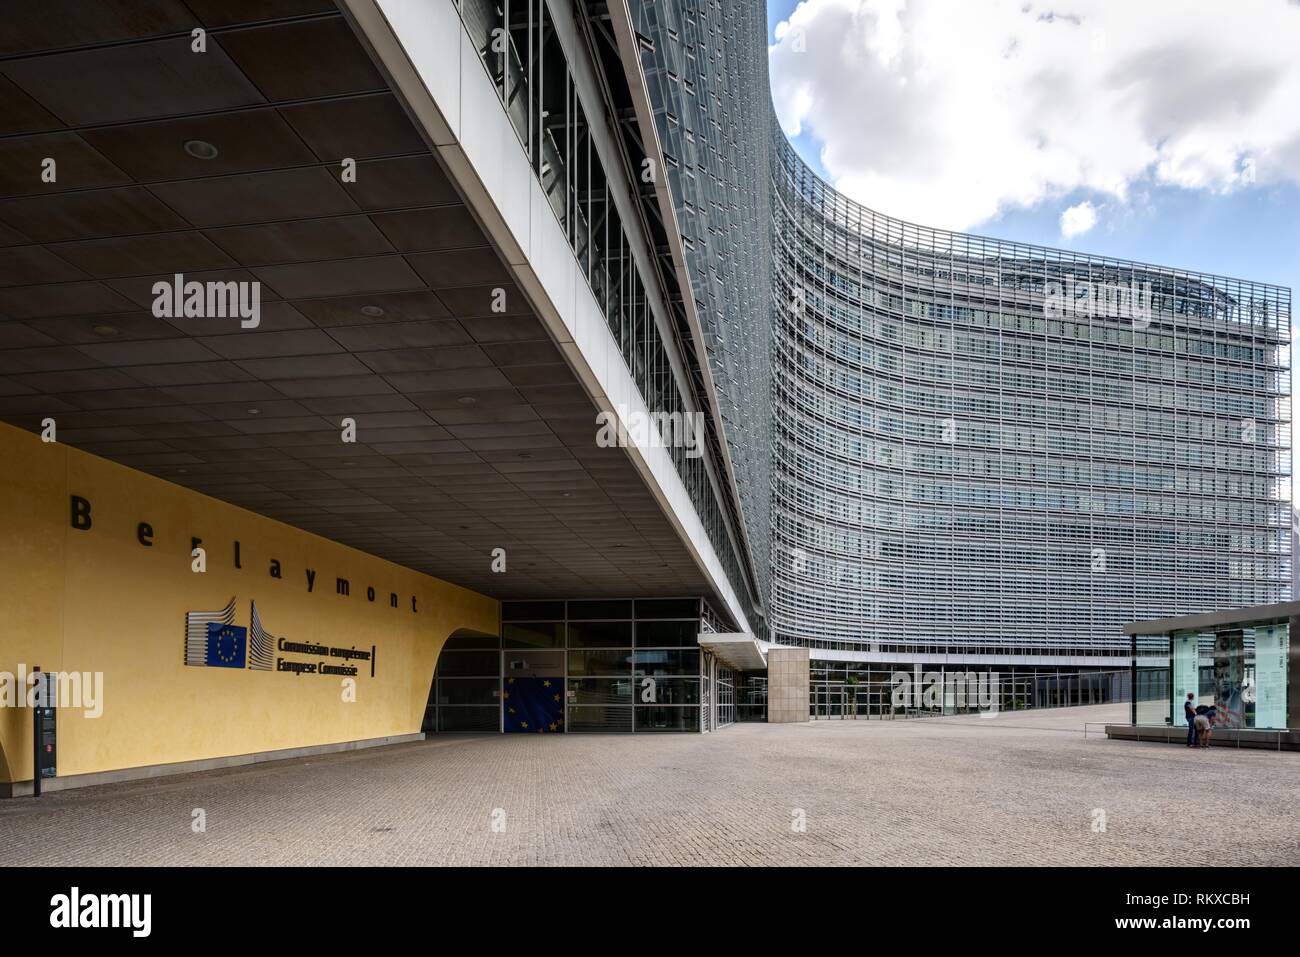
top-left (771, 139), bottom-right (1291, 654)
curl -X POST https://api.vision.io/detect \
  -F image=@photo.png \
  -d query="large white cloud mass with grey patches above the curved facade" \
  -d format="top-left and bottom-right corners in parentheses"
top-left (770, 0), bottom-right (1300, 229)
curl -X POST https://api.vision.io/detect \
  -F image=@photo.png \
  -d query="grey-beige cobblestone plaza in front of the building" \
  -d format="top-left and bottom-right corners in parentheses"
top-left (0, 706), bottom-right (1300, 866)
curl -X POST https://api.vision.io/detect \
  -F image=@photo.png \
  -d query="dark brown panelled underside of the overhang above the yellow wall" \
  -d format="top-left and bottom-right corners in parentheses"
top-left (0, 0), bottom-right (711, 597)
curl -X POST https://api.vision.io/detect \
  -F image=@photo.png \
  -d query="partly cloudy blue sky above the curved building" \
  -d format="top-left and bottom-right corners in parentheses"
top-left (768, 0), bottom-right (1300, 501)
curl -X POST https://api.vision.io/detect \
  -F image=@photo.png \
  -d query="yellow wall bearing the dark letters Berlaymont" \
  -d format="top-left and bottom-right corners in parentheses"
top-left (0, 424), bottom-right (501, 781)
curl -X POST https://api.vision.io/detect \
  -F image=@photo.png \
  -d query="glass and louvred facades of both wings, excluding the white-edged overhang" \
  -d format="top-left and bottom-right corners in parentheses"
top-left (436, 0), bottom-right (1291, 716)
